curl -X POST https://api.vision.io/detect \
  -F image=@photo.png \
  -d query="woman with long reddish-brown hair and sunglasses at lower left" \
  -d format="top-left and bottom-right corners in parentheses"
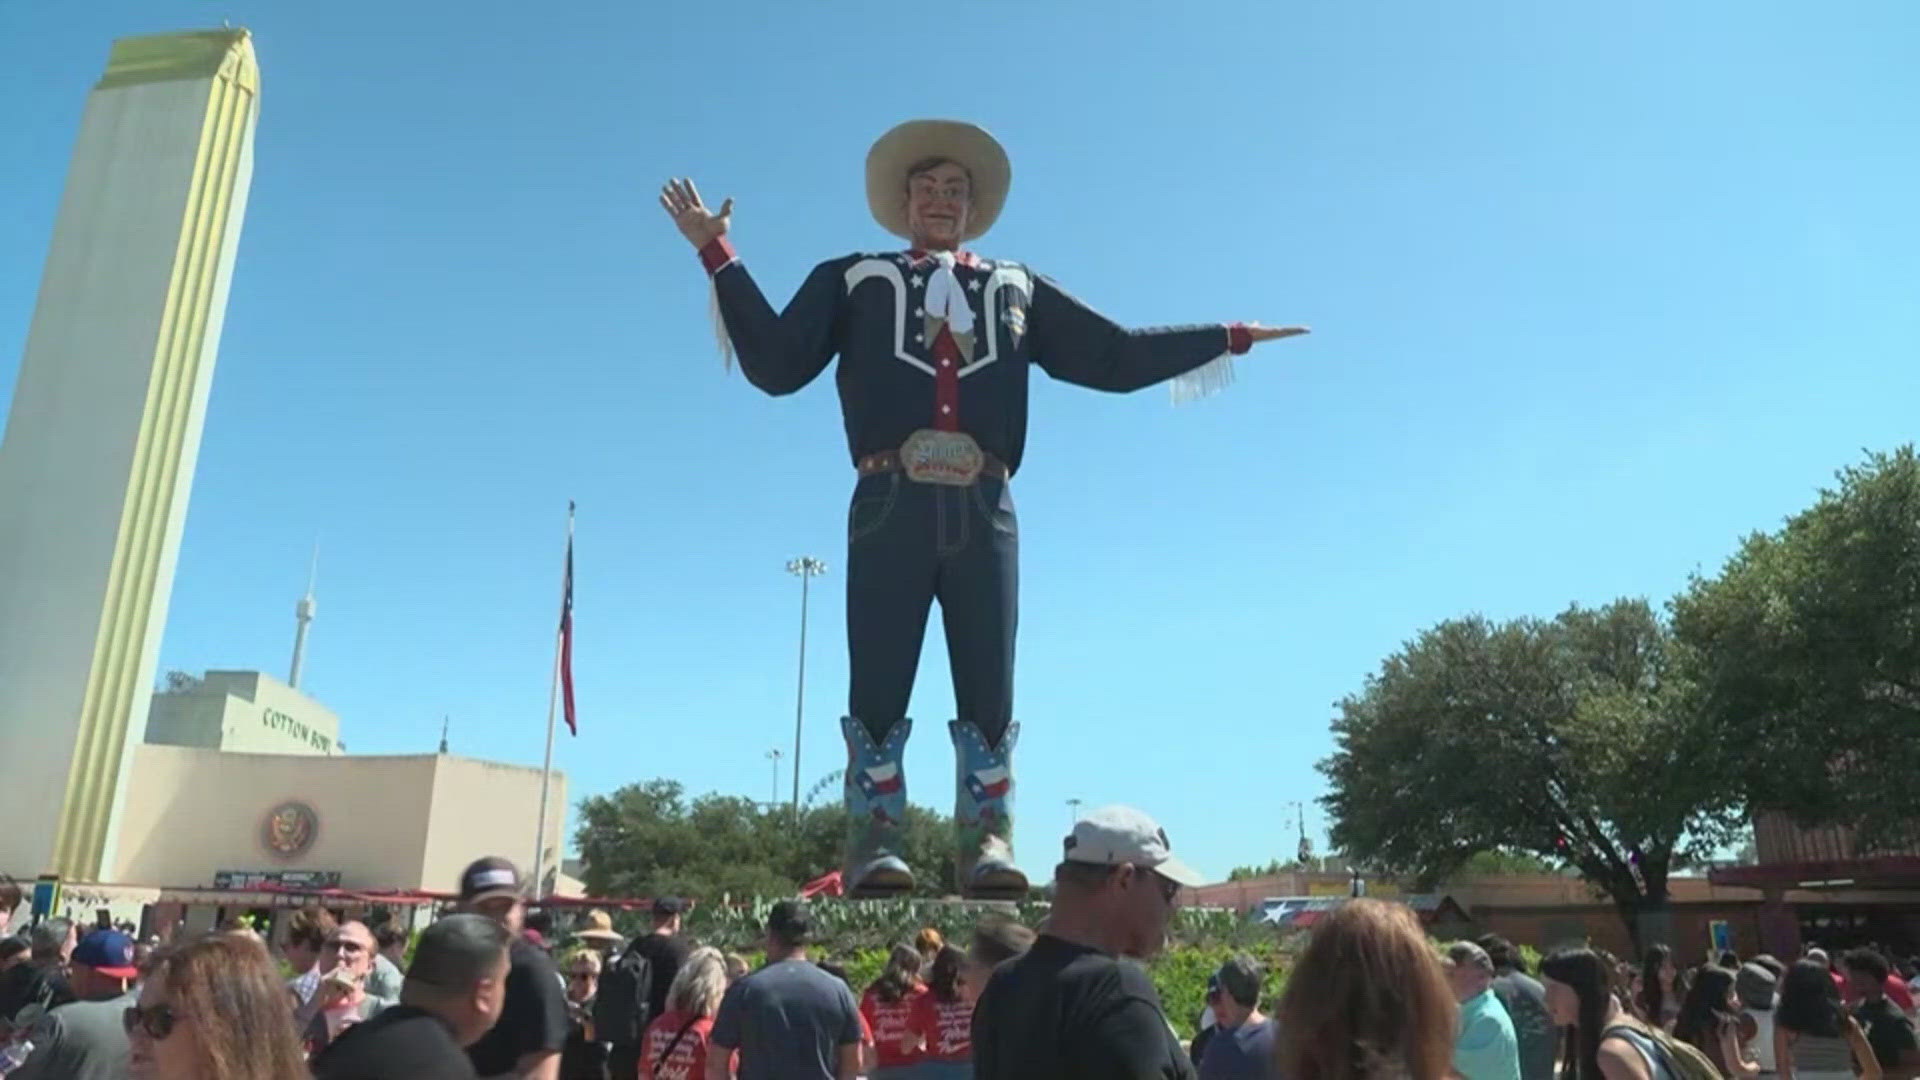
top-left (125, 934), bottom-right (307, 1080)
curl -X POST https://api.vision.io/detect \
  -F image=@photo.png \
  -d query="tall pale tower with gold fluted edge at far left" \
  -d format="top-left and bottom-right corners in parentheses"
top-left (0, 31), bottom-right (259, 880)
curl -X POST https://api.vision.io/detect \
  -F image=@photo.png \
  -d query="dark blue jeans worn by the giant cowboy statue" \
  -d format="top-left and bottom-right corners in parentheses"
top-left (847, 473), bottom-right (1020, 744)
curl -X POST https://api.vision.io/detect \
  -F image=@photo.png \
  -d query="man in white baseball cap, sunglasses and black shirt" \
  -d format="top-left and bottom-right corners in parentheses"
top-left (973, 807), bottom-right (1202, 1080)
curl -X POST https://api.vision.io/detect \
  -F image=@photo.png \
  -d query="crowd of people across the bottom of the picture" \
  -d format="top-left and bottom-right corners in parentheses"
top-left (0, 807), bottom-right (1920, 1080)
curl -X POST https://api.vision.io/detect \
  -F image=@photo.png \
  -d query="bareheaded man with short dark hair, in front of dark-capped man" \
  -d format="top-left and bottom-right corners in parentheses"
top-left (313, 915), bottom-right (511, 1080)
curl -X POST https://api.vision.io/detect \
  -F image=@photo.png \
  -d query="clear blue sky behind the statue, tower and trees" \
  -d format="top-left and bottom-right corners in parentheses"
top-left (0, 0), bottom-right (1920, 874)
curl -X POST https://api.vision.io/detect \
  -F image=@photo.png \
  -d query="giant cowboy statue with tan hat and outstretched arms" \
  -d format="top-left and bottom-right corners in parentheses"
top-left (660, 121), bottom-right (1306, 899)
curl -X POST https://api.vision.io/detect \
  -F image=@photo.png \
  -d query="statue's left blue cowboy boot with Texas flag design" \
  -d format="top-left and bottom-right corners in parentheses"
top-left (841, 717), bottom-right (914, 899)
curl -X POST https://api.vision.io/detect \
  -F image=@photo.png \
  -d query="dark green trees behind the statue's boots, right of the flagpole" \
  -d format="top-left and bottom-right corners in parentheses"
top-left (574, 778), bottom-right (954, 897)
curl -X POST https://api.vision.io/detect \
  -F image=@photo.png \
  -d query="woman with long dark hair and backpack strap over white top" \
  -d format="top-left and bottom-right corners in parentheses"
top-left (1540, 949), bottom-right (1672, 1080)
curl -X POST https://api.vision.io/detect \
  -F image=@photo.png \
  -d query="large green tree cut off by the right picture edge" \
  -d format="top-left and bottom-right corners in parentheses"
top-left (1674, 446), bottom-right (1920, 851)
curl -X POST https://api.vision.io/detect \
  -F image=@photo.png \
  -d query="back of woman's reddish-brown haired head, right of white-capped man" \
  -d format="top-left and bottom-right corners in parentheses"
top-left (1275, 899), bottom-right (1459, 1080)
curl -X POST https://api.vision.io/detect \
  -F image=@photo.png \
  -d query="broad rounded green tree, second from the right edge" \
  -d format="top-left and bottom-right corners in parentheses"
top-left (1321, 600), bottom-right (1734, 940)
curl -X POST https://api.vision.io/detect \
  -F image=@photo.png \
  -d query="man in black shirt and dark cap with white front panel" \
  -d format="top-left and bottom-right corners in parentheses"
top-left (461, 857), bottom-right (568, 1080)
